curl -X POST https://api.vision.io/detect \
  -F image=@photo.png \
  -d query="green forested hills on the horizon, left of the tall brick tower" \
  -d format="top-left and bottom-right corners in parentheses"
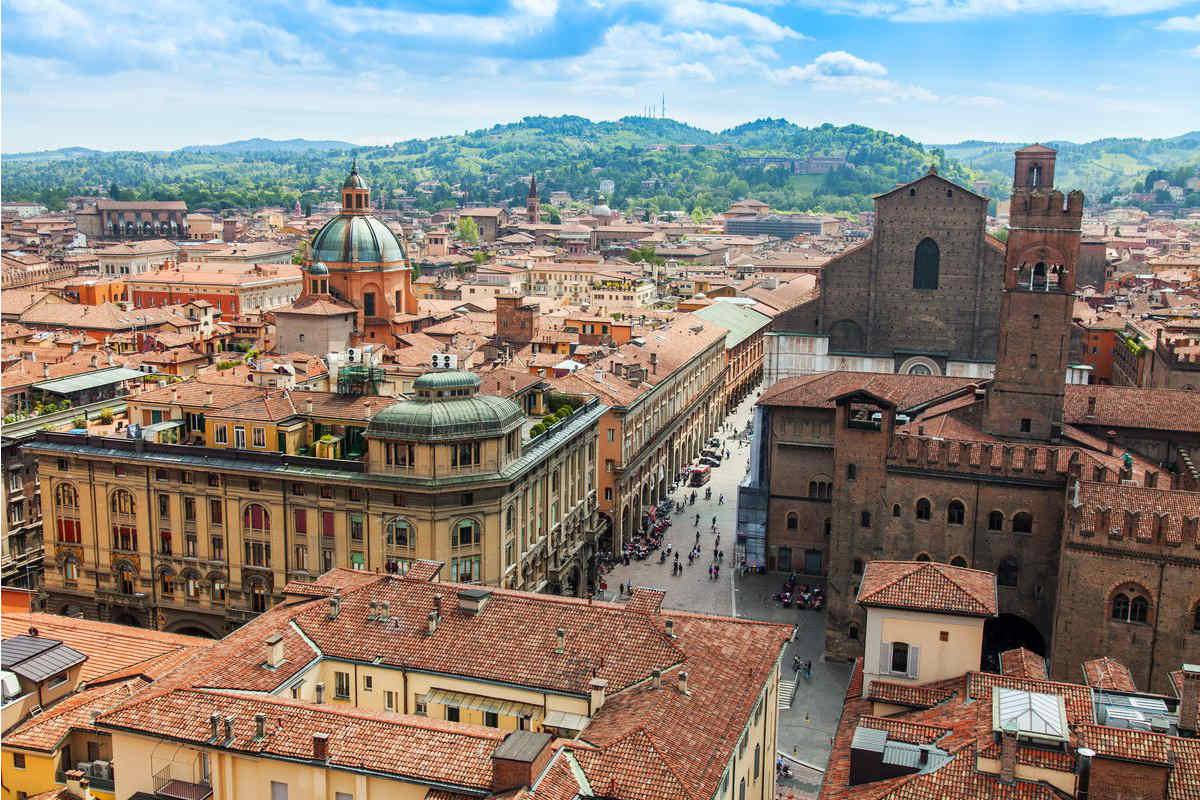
top-left (2, 116), bottom-right (1187, 212)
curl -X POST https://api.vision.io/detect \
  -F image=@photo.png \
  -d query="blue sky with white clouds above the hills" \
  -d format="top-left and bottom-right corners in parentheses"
top-left (0, 0), bottom-right (1200, 152)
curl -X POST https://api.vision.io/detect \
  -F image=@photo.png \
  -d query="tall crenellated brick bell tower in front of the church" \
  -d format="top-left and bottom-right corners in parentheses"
top-left (984, 144), bottom-right (1084, 441)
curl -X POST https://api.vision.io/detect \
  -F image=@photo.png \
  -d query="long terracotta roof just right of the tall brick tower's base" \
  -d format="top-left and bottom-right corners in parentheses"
top-left (1063, 384), bottom-right (1200, 433)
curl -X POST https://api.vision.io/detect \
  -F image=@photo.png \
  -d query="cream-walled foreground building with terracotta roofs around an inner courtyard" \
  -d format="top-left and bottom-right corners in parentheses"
top-left (96, 561), bottom-right (791, 800)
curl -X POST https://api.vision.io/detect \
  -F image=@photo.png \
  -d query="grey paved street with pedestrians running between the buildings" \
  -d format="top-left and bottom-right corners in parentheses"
top-left (605, 383), bottom-right (850, 777)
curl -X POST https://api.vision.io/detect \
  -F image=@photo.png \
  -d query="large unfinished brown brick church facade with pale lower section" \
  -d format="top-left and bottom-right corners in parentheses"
top-left (767, 168), bottom-right (1004, 385)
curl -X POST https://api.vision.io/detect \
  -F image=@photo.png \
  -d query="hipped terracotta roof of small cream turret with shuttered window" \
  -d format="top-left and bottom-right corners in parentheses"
top-left (858, 561), bottom-right (997, 616)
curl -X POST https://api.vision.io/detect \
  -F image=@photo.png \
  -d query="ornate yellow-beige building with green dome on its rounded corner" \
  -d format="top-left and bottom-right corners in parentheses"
top-left (25, 372), bottom-right (604, 636)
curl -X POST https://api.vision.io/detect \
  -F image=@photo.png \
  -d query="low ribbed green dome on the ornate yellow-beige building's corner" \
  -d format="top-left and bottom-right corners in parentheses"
top-left (366, 371), bottom-right (524, 441)
